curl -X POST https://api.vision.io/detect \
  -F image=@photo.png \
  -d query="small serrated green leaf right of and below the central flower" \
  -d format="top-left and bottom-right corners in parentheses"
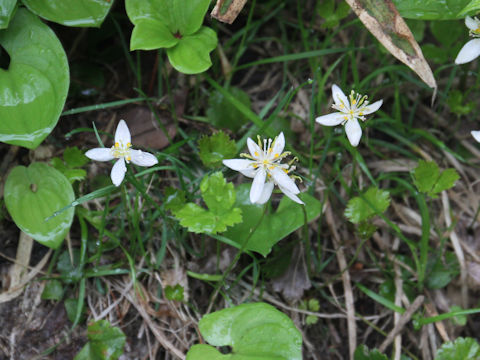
top-left (345, 186), bottom-right (390, 224)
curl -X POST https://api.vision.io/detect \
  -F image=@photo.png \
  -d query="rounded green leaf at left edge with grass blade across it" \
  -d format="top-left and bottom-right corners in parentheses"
top-left (4, 163), bottom-right (75, 249)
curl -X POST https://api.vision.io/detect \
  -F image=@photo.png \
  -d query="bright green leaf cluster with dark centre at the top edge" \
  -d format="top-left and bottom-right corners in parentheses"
top-left (125, 0), bottom-right (218, 74)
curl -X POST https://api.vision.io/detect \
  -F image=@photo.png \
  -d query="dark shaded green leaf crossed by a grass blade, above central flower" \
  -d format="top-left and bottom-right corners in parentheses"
top-left (207, 87), bottom-right (251, 132)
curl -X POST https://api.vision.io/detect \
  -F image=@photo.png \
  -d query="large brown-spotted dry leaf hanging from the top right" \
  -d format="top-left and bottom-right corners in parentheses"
top-left (346, 0), bottom-right (437, 90)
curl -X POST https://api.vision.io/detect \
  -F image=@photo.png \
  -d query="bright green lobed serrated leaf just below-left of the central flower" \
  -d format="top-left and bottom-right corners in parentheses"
top-left (174, 172), bottom-right (242, 234)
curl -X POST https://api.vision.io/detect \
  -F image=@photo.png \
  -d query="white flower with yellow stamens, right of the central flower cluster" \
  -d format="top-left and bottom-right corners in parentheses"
top-left (315, 84), bottom-right (383, 146)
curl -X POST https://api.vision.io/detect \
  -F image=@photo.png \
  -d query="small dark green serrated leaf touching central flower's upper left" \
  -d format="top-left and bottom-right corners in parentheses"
top-left (198, 131), bottom-right (237, 168)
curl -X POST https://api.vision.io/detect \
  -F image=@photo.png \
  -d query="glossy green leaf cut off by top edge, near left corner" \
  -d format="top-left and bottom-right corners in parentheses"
top-left (22, 0), bottom-right (113, 27)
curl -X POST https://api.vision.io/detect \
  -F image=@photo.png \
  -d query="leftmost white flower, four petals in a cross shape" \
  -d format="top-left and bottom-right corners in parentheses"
top-left (85, 120), bottom-right (158, 186)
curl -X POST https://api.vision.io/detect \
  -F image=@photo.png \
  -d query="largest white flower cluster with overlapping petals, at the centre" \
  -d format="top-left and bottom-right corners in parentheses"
top-left (223, 132), bottom-right (304, 204)
